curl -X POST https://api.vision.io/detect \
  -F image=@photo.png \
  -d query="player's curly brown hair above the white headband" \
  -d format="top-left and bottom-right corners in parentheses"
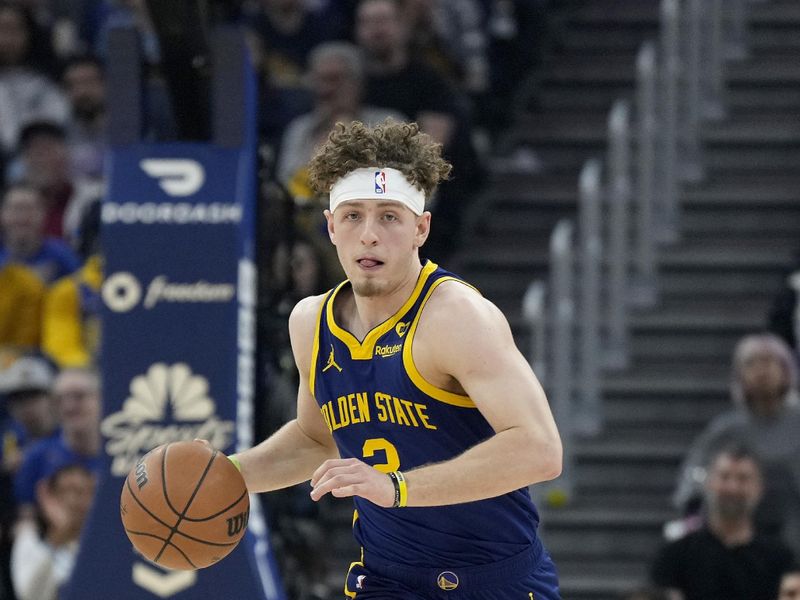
top-left (308, 119), bottom-right (453, 199)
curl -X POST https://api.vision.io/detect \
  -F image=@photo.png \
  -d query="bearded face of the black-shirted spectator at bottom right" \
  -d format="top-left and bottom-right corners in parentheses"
top-left (707, 454), bottom-right (761, 519)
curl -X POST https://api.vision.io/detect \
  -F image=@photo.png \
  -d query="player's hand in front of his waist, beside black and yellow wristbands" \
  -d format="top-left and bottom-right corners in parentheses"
top-left (311, 458), bottom-right (394, 508)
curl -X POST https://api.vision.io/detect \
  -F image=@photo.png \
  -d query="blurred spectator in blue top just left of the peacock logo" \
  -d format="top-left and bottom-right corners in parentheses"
top-left (14, 369), bottom-right (102, 519)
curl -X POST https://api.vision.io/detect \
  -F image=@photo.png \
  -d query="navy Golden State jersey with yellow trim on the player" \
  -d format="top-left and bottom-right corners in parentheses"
top-left (309, 262), bottom-right (539, 567)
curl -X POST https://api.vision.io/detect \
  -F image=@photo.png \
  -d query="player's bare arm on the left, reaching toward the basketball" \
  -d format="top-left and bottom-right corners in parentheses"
top-left (236, 296), bottom-right (339, 492)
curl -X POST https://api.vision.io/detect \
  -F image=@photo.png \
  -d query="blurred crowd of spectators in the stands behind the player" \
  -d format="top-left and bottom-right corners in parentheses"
top-left (0, 0), bottom-right (800, 600)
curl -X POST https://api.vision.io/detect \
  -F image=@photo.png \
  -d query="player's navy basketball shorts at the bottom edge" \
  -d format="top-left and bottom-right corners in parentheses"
top-left (345, 542), bottom-right (561, 600)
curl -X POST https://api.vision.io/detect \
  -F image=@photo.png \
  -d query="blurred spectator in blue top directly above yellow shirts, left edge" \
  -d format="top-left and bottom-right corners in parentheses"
top-left (0, 183), bottom-right (80, 285)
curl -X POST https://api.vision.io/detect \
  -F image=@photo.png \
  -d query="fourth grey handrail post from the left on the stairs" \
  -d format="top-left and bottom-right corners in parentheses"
top-left (604, 100), bottom-right (632, 369)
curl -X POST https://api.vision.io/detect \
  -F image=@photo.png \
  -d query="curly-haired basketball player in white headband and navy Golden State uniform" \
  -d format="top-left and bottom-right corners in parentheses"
top-left (232, 122), bottom-right (561, 600)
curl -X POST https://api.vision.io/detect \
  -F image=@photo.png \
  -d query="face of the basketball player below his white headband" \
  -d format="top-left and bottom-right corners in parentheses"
top-left (325, 200), bottom-right (430, 297)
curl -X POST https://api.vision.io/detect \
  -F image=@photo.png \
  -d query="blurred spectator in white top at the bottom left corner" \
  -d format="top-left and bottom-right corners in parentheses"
top-left (11, 464), bottom-right (96, 600)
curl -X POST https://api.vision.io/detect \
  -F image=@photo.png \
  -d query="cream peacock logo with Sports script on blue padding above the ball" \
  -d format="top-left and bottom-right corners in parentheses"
top-left (100, 363), bottom-right (236, 476)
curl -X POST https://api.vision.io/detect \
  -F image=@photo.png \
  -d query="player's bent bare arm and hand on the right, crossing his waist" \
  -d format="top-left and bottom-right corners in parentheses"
top-left (312, 282), bottom-right (562, 506)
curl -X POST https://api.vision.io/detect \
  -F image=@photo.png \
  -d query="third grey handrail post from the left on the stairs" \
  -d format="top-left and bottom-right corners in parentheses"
top-left (575, 159), bottom-right (604, 435)
